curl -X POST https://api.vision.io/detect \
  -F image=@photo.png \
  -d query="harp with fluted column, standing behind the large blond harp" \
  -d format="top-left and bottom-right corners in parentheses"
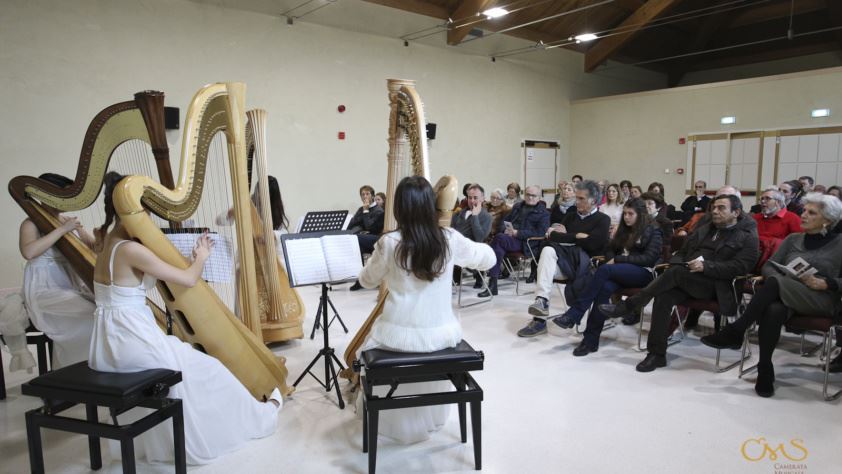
top-left (246, 109), bottom-right (304, 342)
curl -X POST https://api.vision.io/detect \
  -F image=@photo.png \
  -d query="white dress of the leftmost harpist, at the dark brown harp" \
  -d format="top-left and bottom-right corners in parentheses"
top-left (23, 243), bottom-right (95, 369)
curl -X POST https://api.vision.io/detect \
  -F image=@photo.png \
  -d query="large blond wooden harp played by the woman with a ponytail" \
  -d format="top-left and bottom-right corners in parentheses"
top-left (114, 83), bottom-right (292, 399)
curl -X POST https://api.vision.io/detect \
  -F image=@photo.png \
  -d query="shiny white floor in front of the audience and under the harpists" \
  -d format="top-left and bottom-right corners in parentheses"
top-left (0, 285), bottom-right (842, 474)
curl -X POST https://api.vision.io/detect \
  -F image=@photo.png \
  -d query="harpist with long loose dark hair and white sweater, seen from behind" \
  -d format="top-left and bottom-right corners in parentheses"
top-left (358, 176), bottom-right (496, 443)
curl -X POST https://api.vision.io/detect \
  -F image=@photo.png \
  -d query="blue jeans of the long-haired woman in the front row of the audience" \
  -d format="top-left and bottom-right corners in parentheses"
top-left (565, 263), bottom-right (652, 348)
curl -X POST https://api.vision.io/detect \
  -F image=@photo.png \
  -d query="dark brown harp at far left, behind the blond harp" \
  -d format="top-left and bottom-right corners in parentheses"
top-left (9, 91), bottom-right (173, 324)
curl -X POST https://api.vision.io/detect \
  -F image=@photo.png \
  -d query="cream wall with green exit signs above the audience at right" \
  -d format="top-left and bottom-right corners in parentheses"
top-left (569, 68), bottom-right (842, 203)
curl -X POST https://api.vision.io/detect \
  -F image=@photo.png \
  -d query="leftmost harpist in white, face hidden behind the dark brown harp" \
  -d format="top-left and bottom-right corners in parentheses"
top-left (18, 173), bottom-right (94, 369)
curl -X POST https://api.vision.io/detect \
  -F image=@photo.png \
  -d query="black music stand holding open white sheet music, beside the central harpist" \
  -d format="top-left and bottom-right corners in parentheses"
top-left (281, 231), bottom-right (362, 409)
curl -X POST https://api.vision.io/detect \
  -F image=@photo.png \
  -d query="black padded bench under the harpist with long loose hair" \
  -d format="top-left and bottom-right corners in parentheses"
top-left (354, 341), bottom-right (485, 474)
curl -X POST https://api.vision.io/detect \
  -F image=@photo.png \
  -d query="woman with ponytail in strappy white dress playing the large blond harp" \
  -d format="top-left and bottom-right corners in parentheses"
top-left (88, 172), bottom-right (282, 464)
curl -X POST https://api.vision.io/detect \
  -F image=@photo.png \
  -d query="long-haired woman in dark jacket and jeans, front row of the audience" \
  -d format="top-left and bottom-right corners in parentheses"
top-left (559, 199), bottom-right (663, 357)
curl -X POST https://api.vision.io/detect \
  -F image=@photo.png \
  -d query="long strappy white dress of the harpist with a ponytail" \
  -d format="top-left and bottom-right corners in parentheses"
top-left (88, 241), bottom-right (278, 464)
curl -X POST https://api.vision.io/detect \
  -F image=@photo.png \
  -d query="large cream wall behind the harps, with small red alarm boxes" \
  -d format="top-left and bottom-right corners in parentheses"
top-left (0, 0), bottom-right (657, 286)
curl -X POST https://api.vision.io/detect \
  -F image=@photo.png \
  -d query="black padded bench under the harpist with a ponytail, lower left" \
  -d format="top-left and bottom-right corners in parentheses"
top-left (21, 362), bottom-right (187, 474)
